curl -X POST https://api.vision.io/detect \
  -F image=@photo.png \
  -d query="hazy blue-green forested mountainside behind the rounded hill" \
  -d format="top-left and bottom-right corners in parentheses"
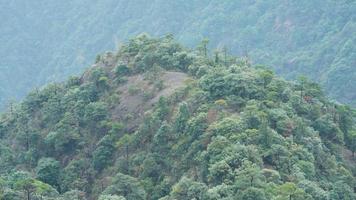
top-left (0, 0), bottom-right (356, 109)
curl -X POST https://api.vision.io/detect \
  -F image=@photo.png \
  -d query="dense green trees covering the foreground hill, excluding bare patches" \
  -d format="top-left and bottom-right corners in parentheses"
top-left (0, 35), bottom-right (356, 200)
